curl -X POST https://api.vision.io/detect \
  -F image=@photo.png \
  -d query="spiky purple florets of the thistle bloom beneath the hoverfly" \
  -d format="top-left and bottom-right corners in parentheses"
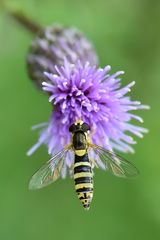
top-left (28, 59), bottom-right (149, 166)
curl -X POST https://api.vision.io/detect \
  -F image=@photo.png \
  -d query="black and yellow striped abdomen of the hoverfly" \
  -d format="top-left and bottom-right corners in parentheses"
top-left (74, 153), bottom-right (93, 209)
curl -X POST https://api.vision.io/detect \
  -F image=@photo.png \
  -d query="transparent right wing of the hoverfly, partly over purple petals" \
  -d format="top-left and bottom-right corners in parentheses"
top-left (90, 144), bottom-right (139, 178)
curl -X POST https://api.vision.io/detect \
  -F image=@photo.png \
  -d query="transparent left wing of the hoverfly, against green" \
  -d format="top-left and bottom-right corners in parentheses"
top-left (29, 147), bottom-right (70, 190)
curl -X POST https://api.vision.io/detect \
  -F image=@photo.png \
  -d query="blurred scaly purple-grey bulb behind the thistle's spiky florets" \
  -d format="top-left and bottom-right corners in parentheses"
top-left (27, 25), bottom-right (98, 89)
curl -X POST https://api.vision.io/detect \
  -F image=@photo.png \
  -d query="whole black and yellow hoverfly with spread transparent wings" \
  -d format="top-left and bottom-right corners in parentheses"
top-left (29, 120), bottom-right (138, 209)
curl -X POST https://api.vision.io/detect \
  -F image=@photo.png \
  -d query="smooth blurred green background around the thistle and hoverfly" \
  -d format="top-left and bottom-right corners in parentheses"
top-left (0, 0), bottom-right (160, 240)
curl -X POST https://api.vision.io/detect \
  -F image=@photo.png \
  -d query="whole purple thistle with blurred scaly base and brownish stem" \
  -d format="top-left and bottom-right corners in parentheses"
top-left (7, 12), bottom-right (149, 166)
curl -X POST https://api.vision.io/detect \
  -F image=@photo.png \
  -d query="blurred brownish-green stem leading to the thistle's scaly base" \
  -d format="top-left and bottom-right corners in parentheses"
top-left (8, 11), bottom-right (43, 34)
